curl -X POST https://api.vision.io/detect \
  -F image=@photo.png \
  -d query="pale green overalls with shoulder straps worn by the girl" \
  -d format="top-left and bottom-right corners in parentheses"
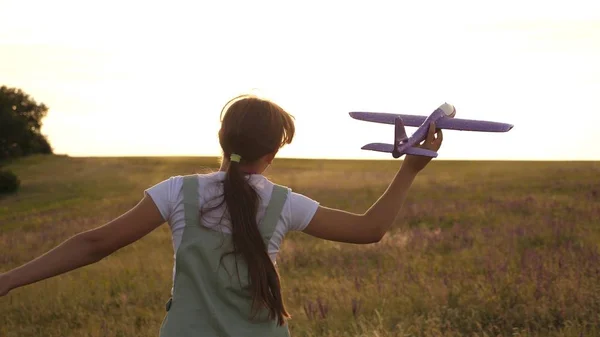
top-left (160, 175), bottom-right (289, 337)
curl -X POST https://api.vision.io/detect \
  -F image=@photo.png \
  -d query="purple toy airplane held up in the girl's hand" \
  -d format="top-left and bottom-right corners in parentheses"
top-left (350, 103), bottom-right (513, 158)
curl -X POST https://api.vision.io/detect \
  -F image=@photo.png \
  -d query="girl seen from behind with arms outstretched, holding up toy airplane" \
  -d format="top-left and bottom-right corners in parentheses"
top-left (0, 95), bottom-right (442, 337)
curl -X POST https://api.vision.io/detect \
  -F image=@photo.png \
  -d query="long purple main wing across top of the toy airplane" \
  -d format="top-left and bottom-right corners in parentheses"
top-left (350, 111), bottom-right (513, 132)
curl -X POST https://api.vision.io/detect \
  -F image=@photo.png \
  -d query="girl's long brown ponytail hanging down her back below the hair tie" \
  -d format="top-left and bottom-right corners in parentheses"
top-left (223, 154), bottom-right (290, 325)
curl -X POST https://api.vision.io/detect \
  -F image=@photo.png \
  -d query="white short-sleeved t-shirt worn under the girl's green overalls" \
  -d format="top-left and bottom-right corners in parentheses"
top-left (146, 171), bottom-right (319, 288)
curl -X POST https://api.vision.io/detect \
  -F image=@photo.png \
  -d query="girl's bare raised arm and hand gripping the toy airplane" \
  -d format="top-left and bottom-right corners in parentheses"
top-left (304, 123), bottom-right (443, 243)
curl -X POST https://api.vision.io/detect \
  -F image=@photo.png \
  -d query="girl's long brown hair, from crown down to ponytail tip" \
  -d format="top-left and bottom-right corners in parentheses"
top-left (219, 95), bottom-right (295, 325)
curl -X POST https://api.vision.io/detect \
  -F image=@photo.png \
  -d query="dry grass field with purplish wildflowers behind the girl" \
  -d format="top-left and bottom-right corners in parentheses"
top-left (0, 156), bottom-right (600, 337)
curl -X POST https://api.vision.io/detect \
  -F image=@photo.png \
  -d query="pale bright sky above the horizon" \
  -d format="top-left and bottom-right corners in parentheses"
top-left (0, 0), bottom-right (600, 160)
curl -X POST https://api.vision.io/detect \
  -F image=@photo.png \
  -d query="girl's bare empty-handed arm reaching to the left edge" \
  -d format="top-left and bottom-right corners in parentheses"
top-left (0, 195), bottom-right (164, 296)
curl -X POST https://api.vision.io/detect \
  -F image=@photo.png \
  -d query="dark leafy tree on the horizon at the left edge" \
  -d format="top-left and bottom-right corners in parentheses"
top-left (0, 86), bottom-right (52, 161)
